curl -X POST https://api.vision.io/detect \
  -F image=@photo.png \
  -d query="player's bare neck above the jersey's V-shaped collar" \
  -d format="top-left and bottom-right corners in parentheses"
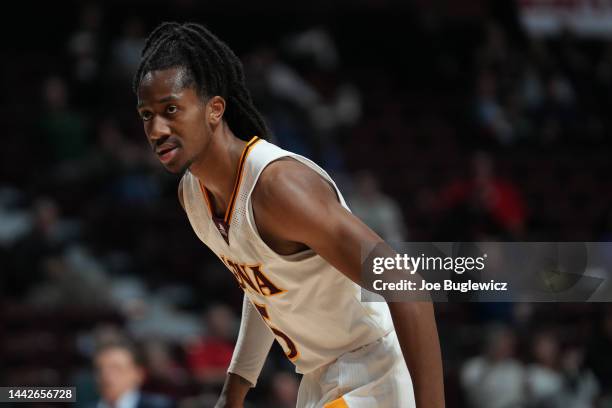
top-left (189, 122), bottom-right (246, 209)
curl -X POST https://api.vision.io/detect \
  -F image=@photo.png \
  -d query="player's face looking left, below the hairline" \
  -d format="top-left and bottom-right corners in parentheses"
top-left (138, 68), bottom-right (212, 173)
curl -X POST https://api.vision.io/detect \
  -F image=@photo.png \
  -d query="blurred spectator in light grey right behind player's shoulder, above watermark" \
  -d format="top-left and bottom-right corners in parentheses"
top-left (349, 172), bottom-right (407, 242)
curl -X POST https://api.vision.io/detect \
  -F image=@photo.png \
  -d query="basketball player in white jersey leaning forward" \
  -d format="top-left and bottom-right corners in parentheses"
top-left (134, 23), bottom-right (444, 408)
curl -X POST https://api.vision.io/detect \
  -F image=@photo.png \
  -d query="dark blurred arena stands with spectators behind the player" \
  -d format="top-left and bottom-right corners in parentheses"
top-left (0, 0), bottom-right (612, 408)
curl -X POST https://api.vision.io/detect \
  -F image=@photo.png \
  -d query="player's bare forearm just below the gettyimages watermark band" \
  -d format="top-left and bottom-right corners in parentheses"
top-left (389, 302), bottom-right (444, 408)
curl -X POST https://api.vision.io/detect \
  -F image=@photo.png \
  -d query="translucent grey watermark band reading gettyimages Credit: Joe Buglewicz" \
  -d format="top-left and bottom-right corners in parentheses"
top-left (362, 242), bottom-right (612, 302)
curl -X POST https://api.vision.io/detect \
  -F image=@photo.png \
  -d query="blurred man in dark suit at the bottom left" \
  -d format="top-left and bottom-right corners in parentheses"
top-left (94, 343), bottom-right (175, 408)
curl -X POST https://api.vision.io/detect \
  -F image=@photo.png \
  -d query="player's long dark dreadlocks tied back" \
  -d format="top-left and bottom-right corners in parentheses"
top-left (132, 22), bottom-right (269, 140)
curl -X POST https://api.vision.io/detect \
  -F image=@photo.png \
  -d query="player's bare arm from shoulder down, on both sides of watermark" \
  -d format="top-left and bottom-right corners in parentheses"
top-left (253, 160), bottom-right (444, 408)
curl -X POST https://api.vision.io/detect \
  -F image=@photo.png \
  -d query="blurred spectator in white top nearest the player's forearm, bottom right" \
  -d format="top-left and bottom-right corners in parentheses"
top-left (461, 327), bottom-right (525, 408)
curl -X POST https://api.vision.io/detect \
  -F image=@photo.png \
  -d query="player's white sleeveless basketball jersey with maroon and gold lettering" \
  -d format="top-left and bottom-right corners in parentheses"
top-left (183, 137), bottom-right (393, 373)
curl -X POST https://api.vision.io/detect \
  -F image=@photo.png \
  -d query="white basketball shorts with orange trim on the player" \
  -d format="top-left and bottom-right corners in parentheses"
top-left (297, 331), bottom-right (416, 408)
